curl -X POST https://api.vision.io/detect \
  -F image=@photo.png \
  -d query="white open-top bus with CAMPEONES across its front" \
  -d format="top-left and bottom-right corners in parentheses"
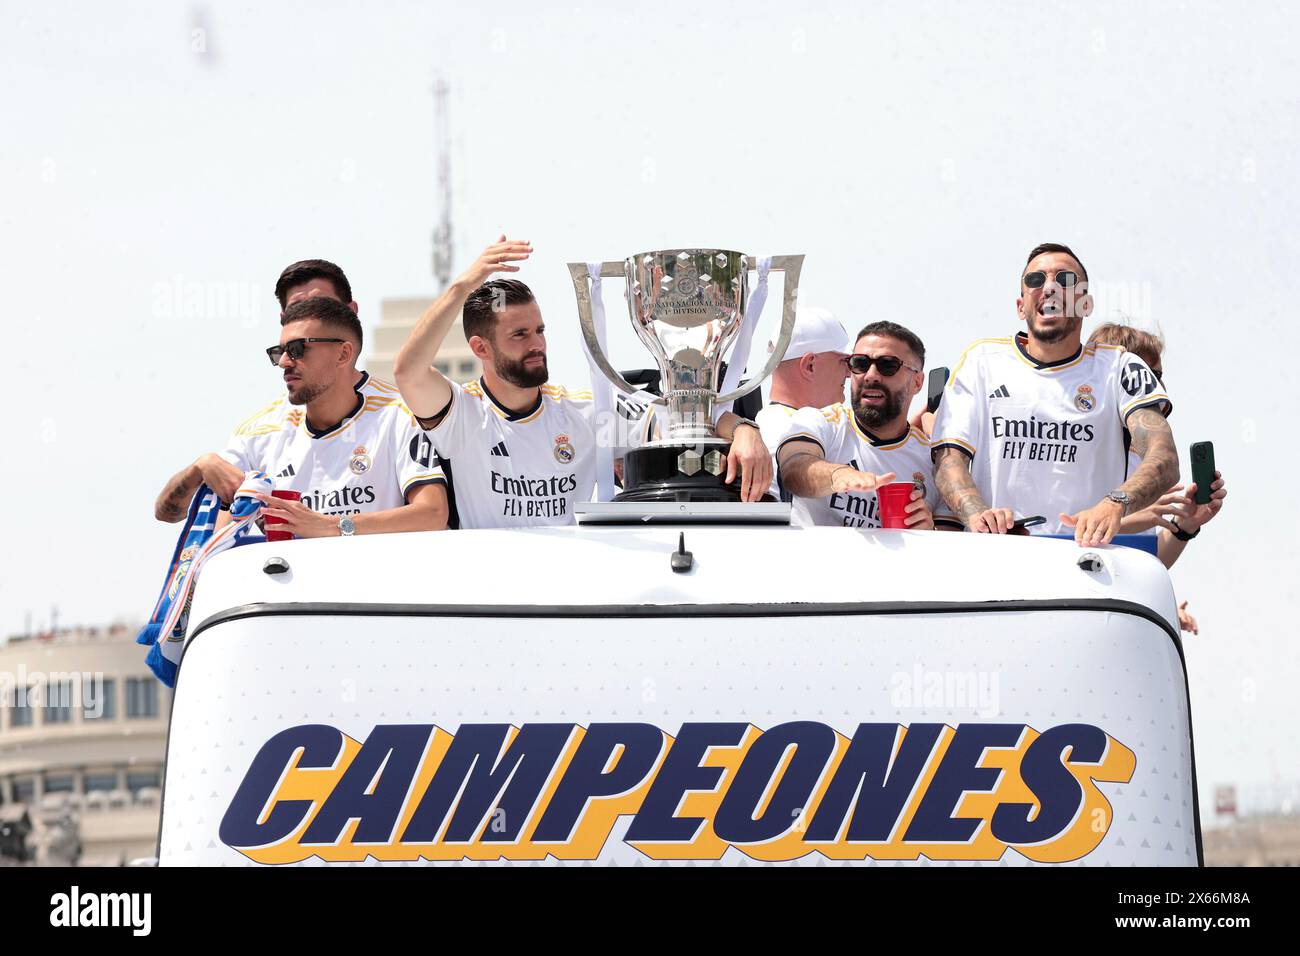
top-left (159, 506), bottom-right (1201, 866)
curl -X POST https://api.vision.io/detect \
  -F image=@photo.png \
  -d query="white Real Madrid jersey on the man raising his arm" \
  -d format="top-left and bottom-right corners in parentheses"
top-left (428, 378), bottom-right (608, 528)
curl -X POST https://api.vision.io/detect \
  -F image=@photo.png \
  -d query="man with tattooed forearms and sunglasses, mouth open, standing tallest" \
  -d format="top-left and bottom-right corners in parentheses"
top-left (933, 243), bottom-right (1178, 548)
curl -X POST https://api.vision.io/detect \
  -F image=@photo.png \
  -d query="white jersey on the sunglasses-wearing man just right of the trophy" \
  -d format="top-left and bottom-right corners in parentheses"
top-left (777, 402), bottom-right (939, 528)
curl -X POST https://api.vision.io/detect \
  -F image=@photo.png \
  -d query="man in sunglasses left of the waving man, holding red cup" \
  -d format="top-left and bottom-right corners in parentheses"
top-left (150, 295), bottom-right (447, 537)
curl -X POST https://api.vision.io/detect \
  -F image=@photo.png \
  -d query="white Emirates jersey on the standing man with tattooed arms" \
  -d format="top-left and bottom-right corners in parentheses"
top-left (933, 333), bottom-right (1171, 535)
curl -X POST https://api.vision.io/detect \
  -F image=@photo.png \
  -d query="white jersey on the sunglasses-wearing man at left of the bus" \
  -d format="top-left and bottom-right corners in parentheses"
top-left (220, 372), bottom-right (446, 515)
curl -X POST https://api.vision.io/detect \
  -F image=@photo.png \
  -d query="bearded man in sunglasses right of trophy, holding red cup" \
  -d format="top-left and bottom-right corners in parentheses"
top-left (776, 321), bottom-right (937, 529)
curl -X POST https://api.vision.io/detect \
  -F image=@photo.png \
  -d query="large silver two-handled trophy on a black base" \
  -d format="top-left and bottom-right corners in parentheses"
top-left (568, 248), bottom-right (803, 502)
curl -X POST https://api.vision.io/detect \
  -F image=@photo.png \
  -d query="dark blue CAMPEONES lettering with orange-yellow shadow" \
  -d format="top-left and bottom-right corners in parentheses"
top-left (220, 721), bottom-right (1136, 864)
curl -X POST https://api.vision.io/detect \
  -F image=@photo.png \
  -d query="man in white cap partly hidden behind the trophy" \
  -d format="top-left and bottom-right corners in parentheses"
top-left (755, 306), bottom-right (849, 497)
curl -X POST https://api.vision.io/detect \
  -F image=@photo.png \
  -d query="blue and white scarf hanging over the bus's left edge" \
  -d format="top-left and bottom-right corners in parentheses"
top-left (135, 471), bottom-right (273, 687)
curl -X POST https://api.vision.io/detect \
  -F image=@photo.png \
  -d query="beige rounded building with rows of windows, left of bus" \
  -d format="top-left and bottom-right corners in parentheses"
top-left (0, 626), bottom-right (172, 865)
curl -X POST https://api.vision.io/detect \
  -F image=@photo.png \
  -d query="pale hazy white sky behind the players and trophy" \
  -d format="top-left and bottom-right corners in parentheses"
top-left (0, 0), bottom-right (1300, 816)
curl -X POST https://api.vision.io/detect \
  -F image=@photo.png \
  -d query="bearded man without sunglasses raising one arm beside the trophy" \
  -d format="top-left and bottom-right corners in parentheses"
top-left (393, 235), bottom-right (772, 528)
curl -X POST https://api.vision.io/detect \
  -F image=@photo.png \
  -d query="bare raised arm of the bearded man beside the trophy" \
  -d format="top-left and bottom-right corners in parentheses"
top-left (393, 235), bottom-right (533, 419)
